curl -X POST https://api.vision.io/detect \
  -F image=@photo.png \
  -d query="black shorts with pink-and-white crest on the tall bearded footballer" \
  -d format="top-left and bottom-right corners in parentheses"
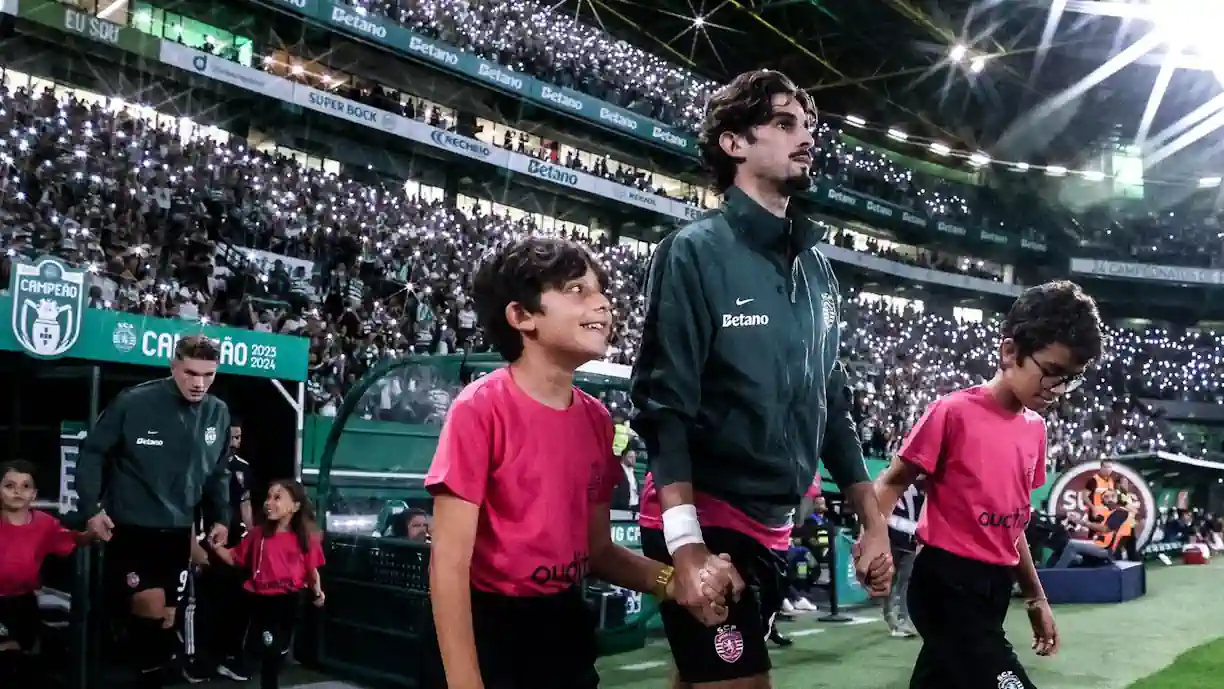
top-left (641, 529), bottom-right (787, 683)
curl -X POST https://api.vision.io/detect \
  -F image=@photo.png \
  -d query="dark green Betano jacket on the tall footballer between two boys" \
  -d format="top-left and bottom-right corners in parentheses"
top-left (632, 187), bottom-right (868, 526)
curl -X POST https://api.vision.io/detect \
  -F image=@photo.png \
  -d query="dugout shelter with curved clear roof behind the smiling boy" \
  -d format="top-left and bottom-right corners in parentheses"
top-left (313, 354), bottom-right (656, 687)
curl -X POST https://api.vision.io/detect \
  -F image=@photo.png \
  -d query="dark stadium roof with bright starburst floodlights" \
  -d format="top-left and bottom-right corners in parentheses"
top-left (557, 0), bottom-right (1224, 176)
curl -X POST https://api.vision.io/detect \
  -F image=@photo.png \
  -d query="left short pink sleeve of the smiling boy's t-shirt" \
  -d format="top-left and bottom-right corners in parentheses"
top-left (425, 395), bottom-right (493, 504)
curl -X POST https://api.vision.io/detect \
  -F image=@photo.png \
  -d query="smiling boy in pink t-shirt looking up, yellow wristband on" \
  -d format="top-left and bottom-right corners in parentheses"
top-left (424, 237), bottom-right (743, 689)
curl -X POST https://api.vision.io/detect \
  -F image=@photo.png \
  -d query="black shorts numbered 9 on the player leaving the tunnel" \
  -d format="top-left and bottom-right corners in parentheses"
top-left (104, 525), bottom-right (191, 605)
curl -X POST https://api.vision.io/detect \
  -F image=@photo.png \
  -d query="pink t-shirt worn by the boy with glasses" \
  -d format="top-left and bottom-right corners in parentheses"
top-left (897, 385), bottom-right (1045, 567)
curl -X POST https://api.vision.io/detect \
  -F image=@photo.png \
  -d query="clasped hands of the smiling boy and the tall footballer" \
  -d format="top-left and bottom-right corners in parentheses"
top-left (667, 543), bottom-right (744, 627)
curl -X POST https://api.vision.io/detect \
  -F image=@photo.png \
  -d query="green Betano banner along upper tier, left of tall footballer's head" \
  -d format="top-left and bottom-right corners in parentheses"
top-left (255, 0), bottom-right (698, 158)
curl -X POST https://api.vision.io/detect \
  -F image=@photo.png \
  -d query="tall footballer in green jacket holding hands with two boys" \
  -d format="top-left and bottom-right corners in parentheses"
top-left (633, 70), bottom-right (892, 689)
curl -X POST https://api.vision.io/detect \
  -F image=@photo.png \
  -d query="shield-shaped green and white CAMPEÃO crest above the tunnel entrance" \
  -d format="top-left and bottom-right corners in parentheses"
top-left (10, 258), bottom-right (86, 357)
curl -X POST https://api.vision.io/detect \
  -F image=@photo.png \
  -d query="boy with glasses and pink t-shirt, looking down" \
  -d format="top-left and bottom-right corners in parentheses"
top-left (876, 280), bottom-right (1102, 689)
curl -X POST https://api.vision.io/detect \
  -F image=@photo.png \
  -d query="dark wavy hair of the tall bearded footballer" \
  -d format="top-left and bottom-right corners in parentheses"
top-left (700, 70), bottom-right (816, 193)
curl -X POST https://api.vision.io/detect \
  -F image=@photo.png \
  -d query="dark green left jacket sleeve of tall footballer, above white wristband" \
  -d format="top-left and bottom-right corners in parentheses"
top-left (630, 234), bottom-right (715, 488)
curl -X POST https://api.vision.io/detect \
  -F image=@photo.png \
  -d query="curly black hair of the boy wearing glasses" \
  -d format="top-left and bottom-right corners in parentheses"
top-left (1002, 280), bottom-right (1103, 365)
